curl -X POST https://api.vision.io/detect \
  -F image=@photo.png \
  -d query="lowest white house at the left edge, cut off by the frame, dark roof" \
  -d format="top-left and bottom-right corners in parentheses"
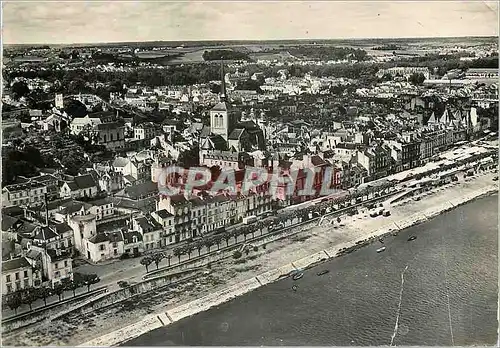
top-left (2, 257), bottom-right (41, 294)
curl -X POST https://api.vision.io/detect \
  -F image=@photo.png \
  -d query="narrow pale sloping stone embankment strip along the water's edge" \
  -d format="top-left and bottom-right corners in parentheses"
top-left (80, 185), bottom-right (498, 347)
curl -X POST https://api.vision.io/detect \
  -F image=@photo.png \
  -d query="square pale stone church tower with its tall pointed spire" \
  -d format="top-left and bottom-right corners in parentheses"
top-left (210, 61), bottom-right (238, 141)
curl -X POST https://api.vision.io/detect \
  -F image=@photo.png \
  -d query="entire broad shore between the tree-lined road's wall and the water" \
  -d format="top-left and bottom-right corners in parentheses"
top-left (3, 173), bottom-right (498, 346)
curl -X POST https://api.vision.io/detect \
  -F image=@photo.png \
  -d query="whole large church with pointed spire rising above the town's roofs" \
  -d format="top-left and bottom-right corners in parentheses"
top-left (199, 63), bottom-right (266, 170)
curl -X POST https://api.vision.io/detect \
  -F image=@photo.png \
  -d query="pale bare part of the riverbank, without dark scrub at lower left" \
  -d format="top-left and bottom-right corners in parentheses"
top-left (71, 174), bottom-right (498, 346)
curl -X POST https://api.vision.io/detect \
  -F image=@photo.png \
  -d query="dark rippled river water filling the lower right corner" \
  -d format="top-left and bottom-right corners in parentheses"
top-left (125, 195), bottom-right (498, 346)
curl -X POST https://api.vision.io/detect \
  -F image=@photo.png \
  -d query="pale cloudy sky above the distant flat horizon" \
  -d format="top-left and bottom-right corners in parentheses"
top-left (2, 0), bottom-right (498, 44)
